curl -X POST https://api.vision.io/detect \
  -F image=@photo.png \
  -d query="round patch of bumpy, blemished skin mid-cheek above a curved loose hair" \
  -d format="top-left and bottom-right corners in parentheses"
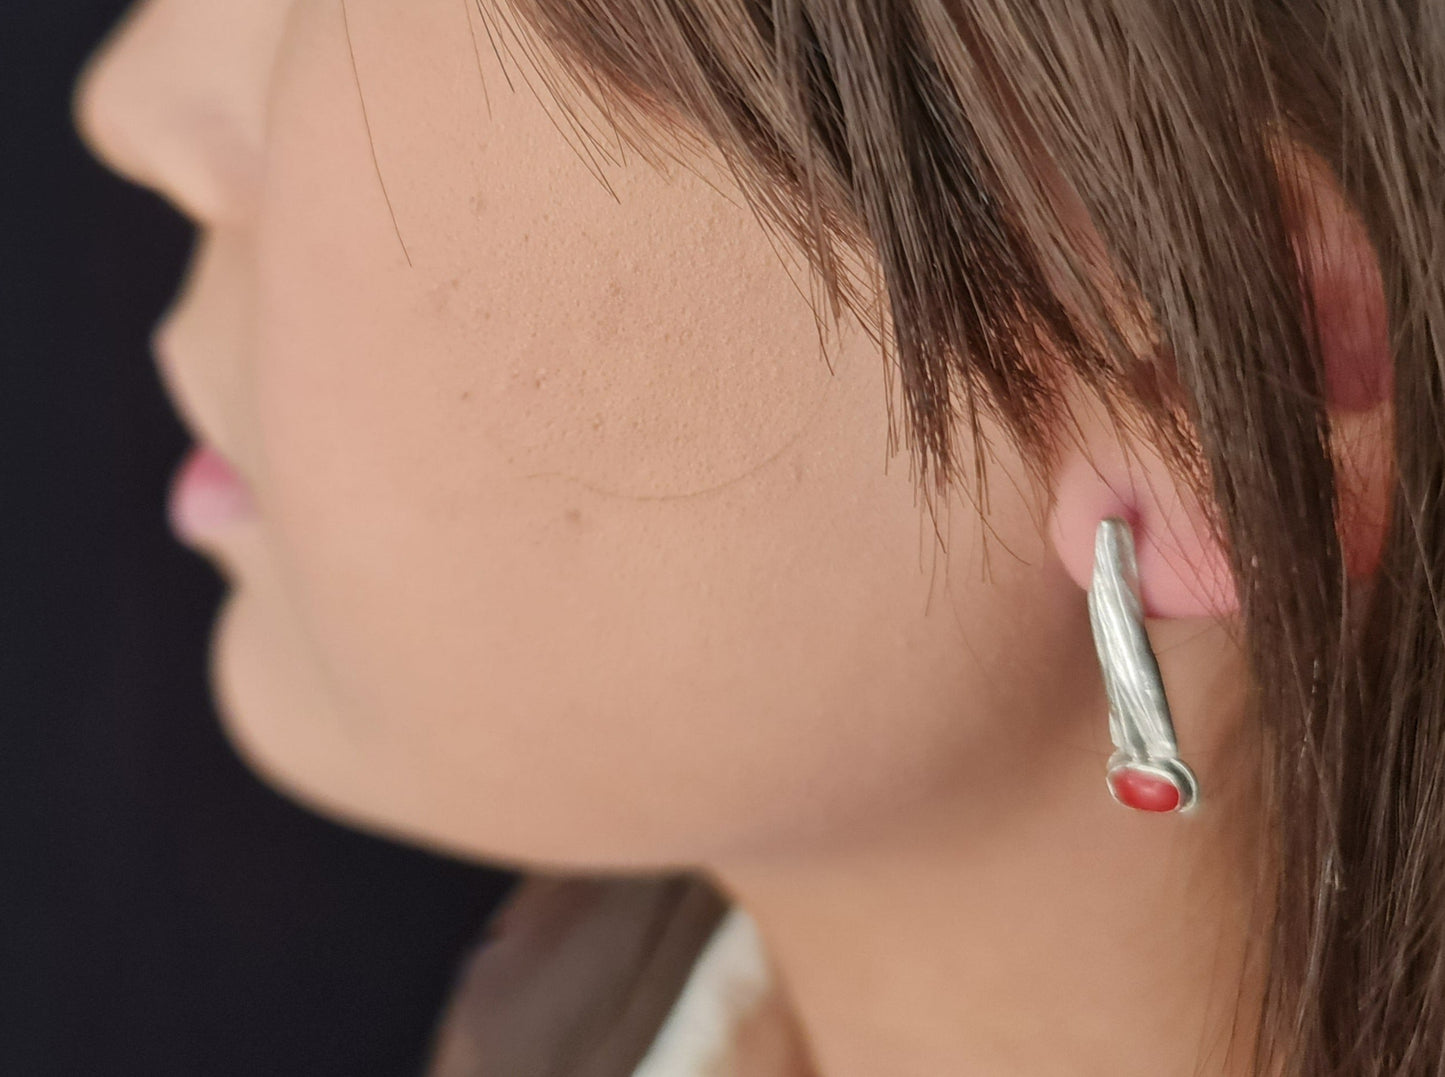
top-left (455, 181), bottom-right (831, 499)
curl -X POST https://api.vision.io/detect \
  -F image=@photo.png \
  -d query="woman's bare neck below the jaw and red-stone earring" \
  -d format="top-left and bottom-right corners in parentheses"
top-left (715, 618), bottom-right (1264, 1077)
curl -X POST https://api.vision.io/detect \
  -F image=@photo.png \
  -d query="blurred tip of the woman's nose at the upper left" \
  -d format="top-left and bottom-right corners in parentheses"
top-left (74, 0), bottom-right (285, 224)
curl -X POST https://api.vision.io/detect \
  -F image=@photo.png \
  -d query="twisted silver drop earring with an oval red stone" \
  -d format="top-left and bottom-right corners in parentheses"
top-left (1088, 516), bottom-right (1199, 811)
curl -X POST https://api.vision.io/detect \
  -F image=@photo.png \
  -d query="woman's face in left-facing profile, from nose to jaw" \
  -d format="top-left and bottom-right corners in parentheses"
top-left (78, 0), bottom-right (1080, 866)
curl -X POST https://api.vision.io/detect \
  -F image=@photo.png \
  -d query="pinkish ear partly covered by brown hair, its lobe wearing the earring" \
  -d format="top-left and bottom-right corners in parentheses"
top-left (1049, 146), bottom-right (1393, 617)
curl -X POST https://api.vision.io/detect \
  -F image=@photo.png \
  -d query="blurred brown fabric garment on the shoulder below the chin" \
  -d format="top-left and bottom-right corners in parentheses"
top-left (426, 875), bottom-right (727, 1077)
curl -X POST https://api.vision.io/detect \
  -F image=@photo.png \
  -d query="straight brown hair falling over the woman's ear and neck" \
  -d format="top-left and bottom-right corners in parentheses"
top-left (478, 0), bottom-right (1445, 1077)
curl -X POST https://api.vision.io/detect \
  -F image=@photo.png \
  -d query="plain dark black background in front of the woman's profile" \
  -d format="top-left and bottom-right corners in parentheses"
top-left (0, 0), bottom-right (510, 1077)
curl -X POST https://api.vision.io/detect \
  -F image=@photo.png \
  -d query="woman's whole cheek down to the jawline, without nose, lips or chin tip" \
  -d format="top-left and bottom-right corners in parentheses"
top-left (231, 0), bottom-right (1075, 862)
